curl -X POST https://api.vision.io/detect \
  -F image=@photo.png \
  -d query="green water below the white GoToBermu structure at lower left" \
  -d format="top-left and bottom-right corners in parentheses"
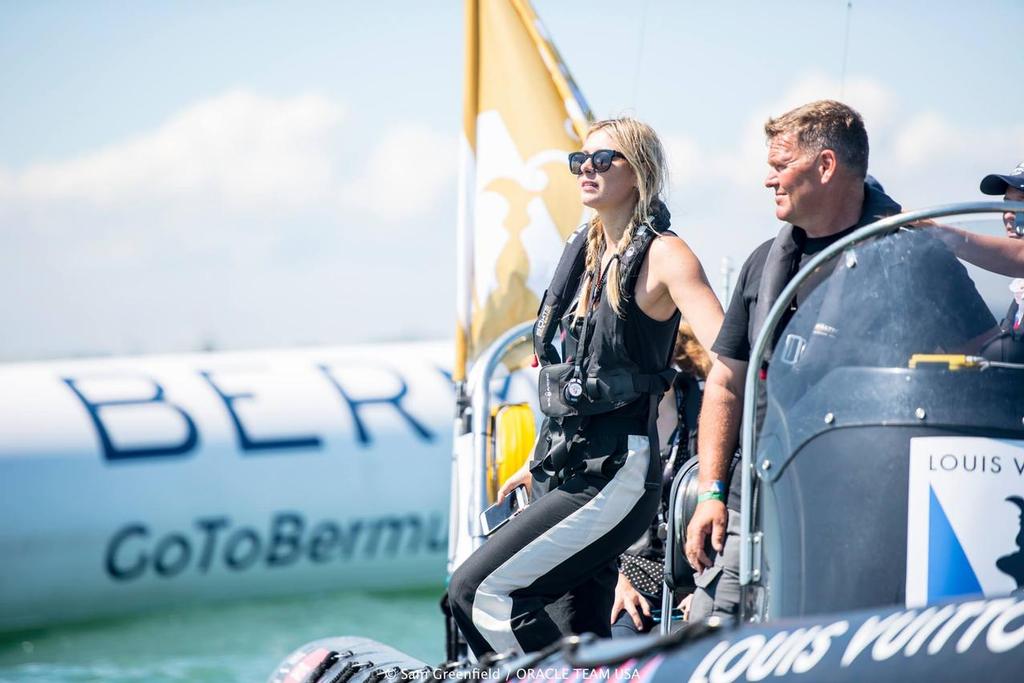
top-left (0, 588), bottom-right (444, 683)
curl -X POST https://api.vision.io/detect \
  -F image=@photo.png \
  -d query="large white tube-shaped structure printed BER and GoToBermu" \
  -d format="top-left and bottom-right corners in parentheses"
top-left (0, 343), bottom-right (530, 631)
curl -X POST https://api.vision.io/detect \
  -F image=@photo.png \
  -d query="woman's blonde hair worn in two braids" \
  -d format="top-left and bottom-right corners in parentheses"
top-left (575, 117), bottom-right (668, 317)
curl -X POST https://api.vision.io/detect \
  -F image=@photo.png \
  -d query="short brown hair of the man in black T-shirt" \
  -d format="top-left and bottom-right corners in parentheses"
top-left (765, 99), bottom-right (868, 177)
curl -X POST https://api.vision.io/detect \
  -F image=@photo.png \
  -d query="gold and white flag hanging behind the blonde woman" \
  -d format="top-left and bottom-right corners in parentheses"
top-left (454, 0), bottom-right (591, 381)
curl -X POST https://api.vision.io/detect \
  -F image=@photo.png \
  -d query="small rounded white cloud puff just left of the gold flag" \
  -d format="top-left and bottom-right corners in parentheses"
top-left (341, 125), bottom-right (458, 222)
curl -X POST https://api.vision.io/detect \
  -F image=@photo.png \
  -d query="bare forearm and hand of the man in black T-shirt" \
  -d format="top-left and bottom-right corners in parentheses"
top-left (685, 355), bottom-right (748, 571)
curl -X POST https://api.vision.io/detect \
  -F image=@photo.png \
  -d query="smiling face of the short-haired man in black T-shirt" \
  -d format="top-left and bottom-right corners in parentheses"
top-left (765, 133), bottom-right (822, 225)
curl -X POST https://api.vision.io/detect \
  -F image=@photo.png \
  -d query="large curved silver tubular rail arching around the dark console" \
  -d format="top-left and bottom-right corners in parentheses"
top-left (739, 202), bottom-right (1024, 586)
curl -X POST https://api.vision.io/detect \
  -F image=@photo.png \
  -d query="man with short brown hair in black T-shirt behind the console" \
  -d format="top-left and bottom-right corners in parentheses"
top-left (685, 100), bottom-right (900, 621)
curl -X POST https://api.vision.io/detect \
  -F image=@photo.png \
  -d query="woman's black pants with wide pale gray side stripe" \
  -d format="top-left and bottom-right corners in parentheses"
top-left (449, 434), bottom-right (662, 657)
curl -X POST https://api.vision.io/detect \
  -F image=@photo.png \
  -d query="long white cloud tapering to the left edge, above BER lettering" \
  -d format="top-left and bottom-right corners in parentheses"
top-left (5, 91), bottom-right (343, 209)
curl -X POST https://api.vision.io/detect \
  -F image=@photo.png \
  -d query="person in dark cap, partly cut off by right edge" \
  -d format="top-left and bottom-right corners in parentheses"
top-left (981, 162), bottom-right (1024, 362)
